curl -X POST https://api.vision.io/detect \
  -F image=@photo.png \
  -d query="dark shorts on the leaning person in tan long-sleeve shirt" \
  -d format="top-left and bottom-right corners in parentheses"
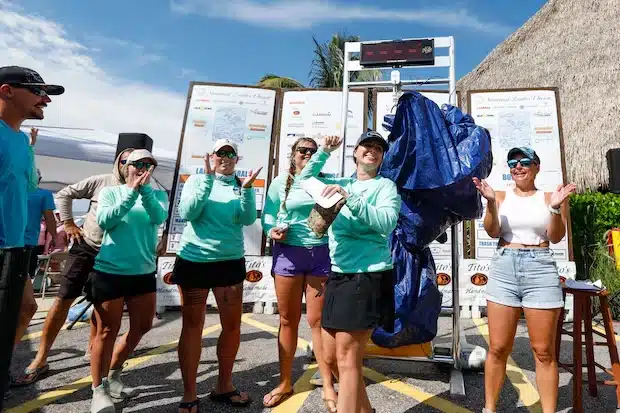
top-left (57, 241), bottom-right (99, 300)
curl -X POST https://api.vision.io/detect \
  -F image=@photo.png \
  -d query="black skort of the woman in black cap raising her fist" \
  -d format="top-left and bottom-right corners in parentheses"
top-left (321, 270), bottom-right (396, 332)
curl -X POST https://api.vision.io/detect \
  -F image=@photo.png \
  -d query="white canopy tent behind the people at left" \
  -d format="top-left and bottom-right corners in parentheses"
top-left (22, 126), bottom-right (176, 192)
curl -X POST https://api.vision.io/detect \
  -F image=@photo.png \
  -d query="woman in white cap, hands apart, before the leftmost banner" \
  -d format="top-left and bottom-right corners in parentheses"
top-left (171, 139), bottom-right (261, 413)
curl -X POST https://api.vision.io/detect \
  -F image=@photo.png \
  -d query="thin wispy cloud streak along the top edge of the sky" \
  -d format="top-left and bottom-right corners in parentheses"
top-left (170, 0), bottom-right (513, 36)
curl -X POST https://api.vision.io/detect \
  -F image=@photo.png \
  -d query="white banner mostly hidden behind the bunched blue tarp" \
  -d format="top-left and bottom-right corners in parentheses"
top-left (375, 92), bottom-right (464, 260)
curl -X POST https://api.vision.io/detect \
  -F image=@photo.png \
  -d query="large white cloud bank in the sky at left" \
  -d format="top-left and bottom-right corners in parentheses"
top-left (0, 0), bottom-right (186, 152)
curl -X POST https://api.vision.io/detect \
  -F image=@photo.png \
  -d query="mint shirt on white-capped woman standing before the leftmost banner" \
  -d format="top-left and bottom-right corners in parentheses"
top-left (177, 174), bottom-right (257, 263)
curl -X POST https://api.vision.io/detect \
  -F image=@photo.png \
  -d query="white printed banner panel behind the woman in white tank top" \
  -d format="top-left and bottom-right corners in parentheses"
top-left (470, 90), bottom-right (569, 261)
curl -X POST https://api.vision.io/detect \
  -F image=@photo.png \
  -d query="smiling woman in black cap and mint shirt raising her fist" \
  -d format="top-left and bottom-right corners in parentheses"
top-left (300, 132), bottom-right (401, 413)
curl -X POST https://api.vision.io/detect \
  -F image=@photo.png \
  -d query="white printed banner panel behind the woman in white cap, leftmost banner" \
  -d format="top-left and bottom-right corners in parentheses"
top-left (167, 85), bottom-right (276, 255)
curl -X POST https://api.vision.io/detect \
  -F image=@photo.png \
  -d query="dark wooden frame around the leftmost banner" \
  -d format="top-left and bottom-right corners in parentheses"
top-left (162, 81), bottom-right (282, 257)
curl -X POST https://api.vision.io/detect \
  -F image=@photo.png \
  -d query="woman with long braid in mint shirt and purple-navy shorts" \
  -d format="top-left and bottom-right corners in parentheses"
top-left (262, 137), bottom-right (331, 407)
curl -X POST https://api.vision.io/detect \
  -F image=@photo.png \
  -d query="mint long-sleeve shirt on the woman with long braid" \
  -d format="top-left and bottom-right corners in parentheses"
top-left (262, 173), bottom-right (328, 247)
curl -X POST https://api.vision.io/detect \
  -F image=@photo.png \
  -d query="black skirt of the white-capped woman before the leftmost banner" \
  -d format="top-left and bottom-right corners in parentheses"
top-left (170, 256), bottom-right (246, 289)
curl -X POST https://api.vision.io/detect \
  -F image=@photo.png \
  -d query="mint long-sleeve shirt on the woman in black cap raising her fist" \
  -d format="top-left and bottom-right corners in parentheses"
top-left (300, 149), bottom-right (401, 273)
